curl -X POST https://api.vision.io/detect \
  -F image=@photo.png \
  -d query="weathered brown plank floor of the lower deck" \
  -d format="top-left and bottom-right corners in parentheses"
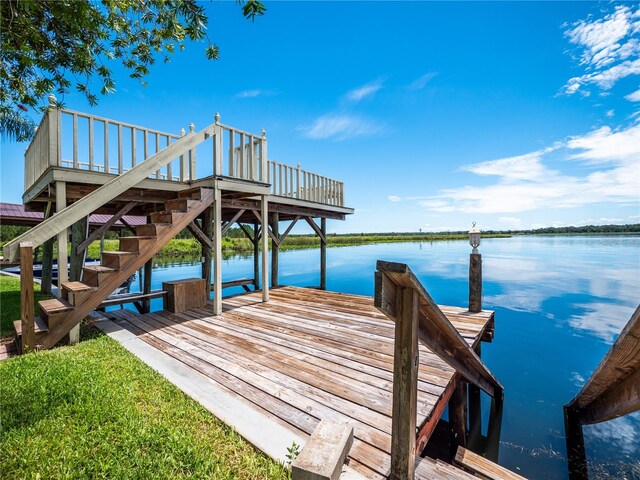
top-left (101, 287), bottom-right (493, 478)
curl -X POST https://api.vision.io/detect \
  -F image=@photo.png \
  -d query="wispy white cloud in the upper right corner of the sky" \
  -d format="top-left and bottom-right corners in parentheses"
top-left (564, 5), bottom-right (640, 95)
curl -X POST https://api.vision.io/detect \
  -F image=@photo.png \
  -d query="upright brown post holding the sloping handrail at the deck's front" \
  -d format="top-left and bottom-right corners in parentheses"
top-left (389, 287), bottom-right (419, 480)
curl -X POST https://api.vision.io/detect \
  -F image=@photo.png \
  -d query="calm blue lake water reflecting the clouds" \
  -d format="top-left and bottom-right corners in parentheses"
top-left (122, 236), bottom-right (640, 479)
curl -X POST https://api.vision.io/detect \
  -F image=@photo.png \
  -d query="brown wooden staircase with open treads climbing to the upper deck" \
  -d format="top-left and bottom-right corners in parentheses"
top-left (13, 188), bottom-right (214, 352)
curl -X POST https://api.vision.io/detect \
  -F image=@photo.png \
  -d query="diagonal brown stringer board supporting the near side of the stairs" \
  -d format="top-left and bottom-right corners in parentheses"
top-left (41, 188), bottom-right (214, 349)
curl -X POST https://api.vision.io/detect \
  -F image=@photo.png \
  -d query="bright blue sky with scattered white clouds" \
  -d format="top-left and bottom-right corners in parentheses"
top-left (0, 2), bottom-right (640, 232)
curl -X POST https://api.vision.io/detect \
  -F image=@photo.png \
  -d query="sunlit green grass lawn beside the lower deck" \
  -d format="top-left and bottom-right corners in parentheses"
top-left (0, 277), bottom-right (289, 479)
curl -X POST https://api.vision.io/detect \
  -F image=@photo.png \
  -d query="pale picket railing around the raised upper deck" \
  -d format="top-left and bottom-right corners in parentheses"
top-left (24, 96), bottom-right (344, 206)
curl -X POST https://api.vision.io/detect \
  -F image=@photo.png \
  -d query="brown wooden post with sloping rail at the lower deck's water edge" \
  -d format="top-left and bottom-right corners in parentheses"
top-left (374, 260), bottom-right (503, 479)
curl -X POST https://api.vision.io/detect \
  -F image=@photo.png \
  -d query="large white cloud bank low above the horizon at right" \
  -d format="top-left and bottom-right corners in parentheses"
top-left (416, 125), bottom-right (640, 214)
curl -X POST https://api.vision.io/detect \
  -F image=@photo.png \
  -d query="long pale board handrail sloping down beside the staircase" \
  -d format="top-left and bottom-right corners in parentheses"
top-left (3, 125), bottom-right (215, 261)
